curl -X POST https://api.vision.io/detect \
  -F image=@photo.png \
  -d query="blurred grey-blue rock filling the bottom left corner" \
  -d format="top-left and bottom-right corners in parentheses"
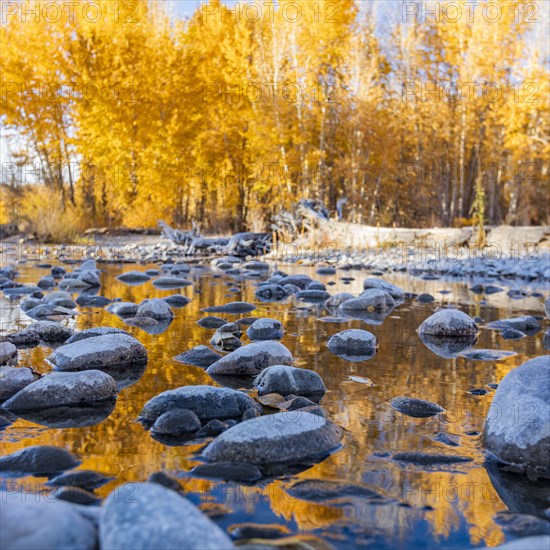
top-left (0, 491), bottom-right (97, 550)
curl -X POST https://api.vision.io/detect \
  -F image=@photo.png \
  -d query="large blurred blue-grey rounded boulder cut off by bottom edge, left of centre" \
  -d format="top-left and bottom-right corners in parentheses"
top-left (99, 483), bottom-right (233, 550)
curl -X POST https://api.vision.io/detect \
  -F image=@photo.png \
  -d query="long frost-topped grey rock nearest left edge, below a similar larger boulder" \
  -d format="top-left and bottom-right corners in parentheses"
top-left (4, 370), bottom-right (117, 413)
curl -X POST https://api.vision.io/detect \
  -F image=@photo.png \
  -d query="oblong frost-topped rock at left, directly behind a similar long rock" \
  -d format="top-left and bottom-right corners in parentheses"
top-left (47, 334), bottom-right (147, 371)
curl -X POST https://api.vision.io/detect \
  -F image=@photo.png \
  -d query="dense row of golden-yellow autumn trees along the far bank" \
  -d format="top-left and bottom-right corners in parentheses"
top-left (0, 0), bottom-right (550, 237)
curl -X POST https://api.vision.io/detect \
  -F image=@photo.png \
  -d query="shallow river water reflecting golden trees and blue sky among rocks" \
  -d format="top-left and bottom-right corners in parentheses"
top-left (0, 265), bottom-right (547, 549)
